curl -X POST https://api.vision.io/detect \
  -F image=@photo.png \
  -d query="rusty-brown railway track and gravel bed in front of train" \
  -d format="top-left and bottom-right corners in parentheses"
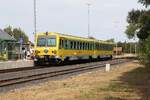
top-left (0, 59), bottom-right (131, 88)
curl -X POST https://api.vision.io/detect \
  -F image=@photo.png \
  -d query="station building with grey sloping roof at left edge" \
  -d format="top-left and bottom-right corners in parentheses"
top-left (0, 29), bottom-right (19, 60)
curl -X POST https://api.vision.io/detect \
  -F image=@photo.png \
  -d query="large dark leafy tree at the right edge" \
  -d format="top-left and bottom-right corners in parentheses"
top-left (125, 0), bottom-right (150, 65)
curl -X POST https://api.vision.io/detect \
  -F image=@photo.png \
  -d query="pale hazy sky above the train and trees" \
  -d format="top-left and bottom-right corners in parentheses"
top-left (0, 0), bottom-right (142, 41)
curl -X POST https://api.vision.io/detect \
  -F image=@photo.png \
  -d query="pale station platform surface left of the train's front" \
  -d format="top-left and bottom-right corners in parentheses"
top-left (0, 60), bottom-right (33, 70)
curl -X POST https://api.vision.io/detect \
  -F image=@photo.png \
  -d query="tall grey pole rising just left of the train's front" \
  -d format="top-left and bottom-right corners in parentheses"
top-left (33, 0), bottom-right (37, 45)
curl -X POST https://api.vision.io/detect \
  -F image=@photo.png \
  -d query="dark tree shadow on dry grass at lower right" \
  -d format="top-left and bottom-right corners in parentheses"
top-left (120, 62), bottom-right (150, 100)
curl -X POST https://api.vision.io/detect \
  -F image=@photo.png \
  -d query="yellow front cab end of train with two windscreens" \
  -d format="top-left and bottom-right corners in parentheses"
top-left (34, 32), bottom-right (61, 64)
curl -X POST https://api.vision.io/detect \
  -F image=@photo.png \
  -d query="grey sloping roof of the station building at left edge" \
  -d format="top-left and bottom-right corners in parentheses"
top-left (0, 29), bottom-right (15, 41)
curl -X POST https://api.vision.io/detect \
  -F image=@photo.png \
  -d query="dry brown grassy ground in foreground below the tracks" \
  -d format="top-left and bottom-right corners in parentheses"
top-left (0, 61), bottom-right (150, 100)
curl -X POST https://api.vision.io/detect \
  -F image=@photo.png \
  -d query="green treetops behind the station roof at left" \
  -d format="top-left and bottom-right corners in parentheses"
top-left (4, 26), bottom-right (29, 43)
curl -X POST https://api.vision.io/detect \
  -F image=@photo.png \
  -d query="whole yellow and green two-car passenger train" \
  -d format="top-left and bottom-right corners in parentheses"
top-left (34, 32), bottom-right (114, 65)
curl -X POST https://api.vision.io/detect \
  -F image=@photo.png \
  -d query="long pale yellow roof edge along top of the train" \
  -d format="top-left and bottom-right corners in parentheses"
top-left (38, 32), bottom-right (114, 44)
